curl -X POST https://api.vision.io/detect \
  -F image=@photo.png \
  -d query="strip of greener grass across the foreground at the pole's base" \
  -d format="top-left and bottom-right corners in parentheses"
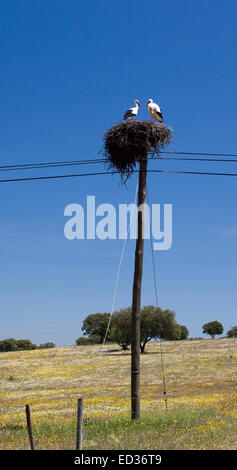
top-left (1, 408), bottom-right (237, 450)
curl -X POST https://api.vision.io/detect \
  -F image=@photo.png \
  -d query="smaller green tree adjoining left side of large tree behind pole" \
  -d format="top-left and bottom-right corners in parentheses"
top-left (82, 313), bottom-right (110, 344)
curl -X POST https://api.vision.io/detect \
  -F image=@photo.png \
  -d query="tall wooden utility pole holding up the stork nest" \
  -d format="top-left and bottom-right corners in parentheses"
top-left (131, 158), bottom-right (147, 420)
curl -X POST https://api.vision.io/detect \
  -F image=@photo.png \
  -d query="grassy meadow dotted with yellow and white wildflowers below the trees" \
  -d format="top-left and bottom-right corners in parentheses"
top-left (0, 338), bottom-right (237, 450)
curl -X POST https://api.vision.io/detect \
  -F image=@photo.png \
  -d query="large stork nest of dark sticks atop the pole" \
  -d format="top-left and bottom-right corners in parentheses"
top-left (103, 121), bottom-right (172, 181)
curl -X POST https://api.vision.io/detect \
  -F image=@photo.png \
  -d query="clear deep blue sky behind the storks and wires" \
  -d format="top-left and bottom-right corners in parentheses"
top-left (0, 0), bottom-right (237, 346)
